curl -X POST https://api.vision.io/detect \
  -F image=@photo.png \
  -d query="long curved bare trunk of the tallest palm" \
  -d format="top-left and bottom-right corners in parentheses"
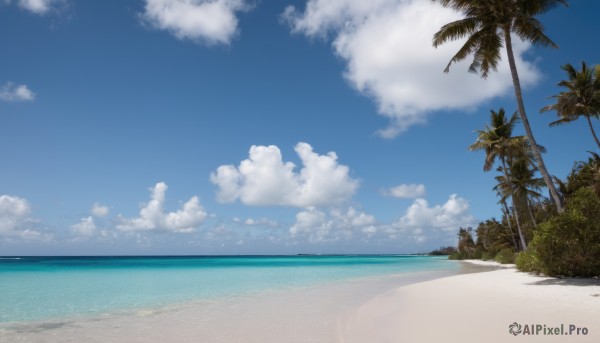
top-left (504, 27), bottom-right (563, 212)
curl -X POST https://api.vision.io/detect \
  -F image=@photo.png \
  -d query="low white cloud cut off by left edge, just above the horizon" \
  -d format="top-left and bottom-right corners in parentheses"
top-left (0, 195), bottom-right (49, 239)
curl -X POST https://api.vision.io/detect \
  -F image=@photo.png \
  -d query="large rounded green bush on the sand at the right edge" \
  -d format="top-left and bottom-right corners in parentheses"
top-left (517, 188), bottom-right (600, 277)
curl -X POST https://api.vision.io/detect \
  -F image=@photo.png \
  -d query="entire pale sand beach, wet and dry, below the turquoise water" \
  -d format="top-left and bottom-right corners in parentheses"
top-left (0, 262), bottom-right (600, 343)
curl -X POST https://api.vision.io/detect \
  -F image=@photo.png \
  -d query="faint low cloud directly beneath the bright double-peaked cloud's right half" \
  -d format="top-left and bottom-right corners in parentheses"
top-left (290, 207), bottom-right (376, 243)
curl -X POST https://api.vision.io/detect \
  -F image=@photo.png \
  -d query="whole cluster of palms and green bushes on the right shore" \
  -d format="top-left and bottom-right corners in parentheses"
top-left (433, 0), bottom-right (600, 277)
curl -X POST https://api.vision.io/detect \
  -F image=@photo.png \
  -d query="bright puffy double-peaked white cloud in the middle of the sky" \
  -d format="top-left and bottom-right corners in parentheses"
top-left (210, 143), bottom-right (358, 207)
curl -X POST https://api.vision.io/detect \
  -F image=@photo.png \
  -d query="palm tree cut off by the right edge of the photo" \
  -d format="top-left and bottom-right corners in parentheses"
top-left (541, 62), bottom-right (600, 148)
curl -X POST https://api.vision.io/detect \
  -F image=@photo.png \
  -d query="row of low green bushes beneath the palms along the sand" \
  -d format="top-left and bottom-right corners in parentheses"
top-left (458, 153), bottom-right (600, 277)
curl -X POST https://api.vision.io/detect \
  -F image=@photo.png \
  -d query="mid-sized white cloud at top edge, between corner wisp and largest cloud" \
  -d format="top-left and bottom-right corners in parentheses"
top-left (141, 0), bottom-right (249, 45)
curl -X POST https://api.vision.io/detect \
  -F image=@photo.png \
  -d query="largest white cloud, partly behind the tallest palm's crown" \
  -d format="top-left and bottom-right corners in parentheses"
top-left (283, 0), bottom-right (540, 138)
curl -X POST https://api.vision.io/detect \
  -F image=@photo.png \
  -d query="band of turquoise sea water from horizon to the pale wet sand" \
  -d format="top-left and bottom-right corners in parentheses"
top-left (0, 255), bottom-right (459, 323)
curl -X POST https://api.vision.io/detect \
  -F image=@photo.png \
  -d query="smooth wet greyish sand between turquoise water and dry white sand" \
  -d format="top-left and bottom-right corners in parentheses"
top-left (0, 268), bottom-right (477, 343)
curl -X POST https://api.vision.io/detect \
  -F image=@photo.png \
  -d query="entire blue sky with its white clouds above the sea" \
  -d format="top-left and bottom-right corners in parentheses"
top-left (0, 0), bottom-right (600, 255)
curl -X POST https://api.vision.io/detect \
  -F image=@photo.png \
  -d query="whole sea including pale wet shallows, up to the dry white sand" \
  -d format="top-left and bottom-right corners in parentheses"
top-left (0, 256), bottom-right (477, 343)
